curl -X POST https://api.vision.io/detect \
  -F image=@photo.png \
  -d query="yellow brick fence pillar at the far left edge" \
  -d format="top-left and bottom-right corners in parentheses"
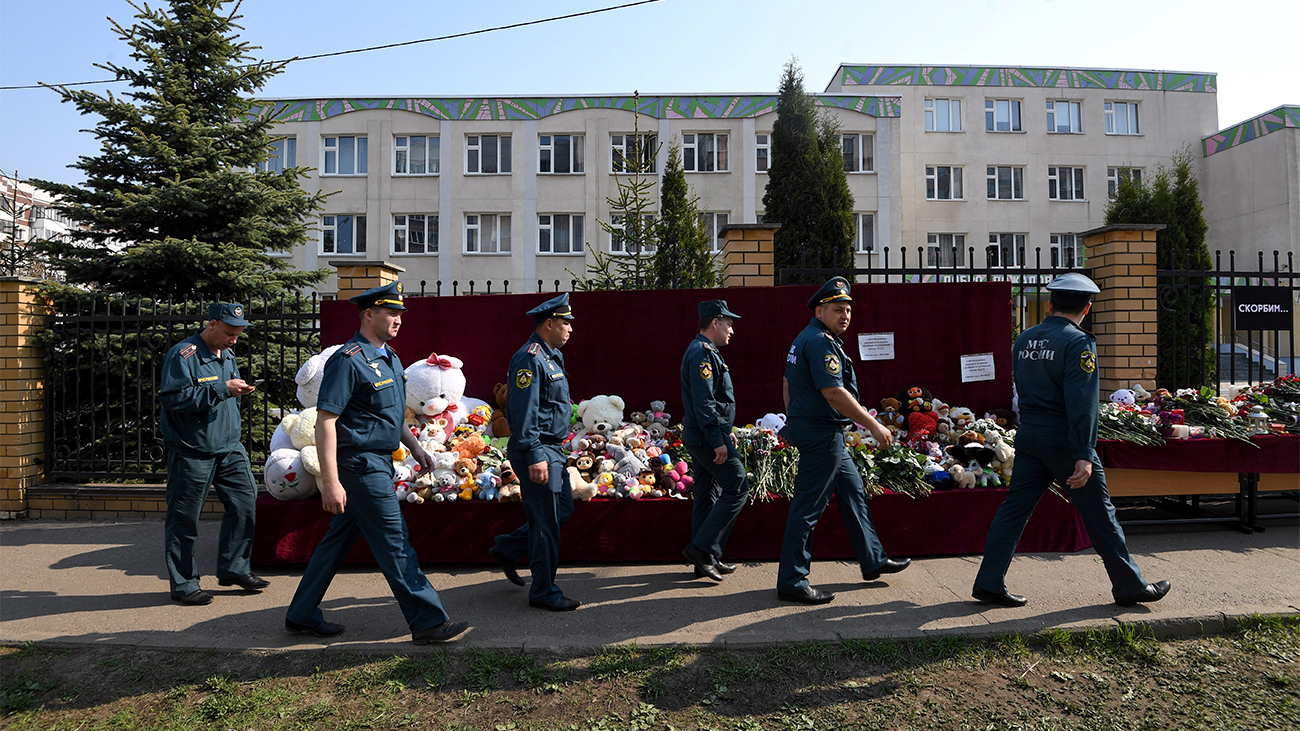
top-left (0, 277), bottom-right (49, 519)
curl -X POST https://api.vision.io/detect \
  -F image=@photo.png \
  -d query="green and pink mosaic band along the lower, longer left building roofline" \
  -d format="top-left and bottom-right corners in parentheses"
top-left (252, 96), bottom-right (901, 122)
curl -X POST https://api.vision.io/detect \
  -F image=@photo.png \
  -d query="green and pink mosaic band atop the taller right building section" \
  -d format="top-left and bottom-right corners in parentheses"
top-left (839, 65), bottom-right (1218, 94)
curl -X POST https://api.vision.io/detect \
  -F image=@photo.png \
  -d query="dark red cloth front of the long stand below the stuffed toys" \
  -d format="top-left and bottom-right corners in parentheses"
top-left (252, 489), bottom-right (1092, 566)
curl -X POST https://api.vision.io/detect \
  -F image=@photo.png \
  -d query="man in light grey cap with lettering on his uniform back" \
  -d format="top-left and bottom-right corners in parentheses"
top-left (971, 273), bottom-right (1169, 606)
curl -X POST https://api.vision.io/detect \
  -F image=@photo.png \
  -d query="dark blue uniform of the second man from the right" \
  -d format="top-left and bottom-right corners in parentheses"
top-left (776, 317), bottom-right (889, 593)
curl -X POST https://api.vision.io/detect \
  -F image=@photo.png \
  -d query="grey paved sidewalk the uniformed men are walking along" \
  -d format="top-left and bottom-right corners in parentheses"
top-left (0, 520), bottom-right (1300, 652)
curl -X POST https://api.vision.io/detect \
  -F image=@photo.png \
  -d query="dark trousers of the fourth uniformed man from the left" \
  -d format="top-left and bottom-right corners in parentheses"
top-left (686, 437), bottom-right (749, 563)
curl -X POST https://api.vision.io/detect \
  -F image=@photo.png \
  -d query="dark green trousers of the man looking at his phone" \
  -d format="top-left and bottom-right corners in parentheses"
top-left (163, 445), bottom-right (257, 597)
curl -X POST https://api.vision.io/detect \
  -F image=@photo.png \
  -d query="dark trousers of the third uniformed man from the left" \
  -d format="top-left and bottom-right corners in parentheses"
top-left (497, 446), bottom-right (573, 602)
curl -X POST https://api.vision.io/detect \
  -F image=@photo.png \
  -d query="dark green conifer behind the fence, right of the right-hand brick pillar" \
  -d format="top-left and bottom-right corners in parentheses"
top-left (1106, 146), bottom-right (1218, 390)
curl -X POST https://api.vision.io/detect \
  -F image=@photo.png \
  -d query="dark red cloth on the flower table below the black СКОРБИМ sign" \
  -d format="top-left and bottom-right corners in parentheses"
top-left (1097, 434), bottom-right (1300, 473)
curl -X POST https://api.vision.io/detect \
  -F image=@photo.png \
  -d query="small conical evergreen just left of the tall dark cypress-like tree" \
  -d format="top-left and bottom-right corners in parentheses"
top-left (654, 138), bottom-right (722, 289)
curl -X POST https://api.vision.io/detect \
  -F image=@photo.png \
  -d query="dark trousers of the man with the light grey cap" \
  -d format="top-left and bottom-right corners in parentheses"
top-left (975, 425), bottom-right (1147, 597)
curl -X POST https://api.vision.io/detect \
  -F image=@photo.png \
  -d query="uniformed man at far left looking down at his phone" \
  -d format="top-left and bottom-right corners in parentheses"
top-left (161, 302), bottom-right (270, 605)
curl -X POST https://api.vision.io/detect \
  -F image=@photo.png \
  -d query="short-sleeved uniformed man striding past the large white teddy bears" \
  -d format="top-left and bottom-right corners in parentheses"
top-left (285, 282), bottom-right (469, 645)
